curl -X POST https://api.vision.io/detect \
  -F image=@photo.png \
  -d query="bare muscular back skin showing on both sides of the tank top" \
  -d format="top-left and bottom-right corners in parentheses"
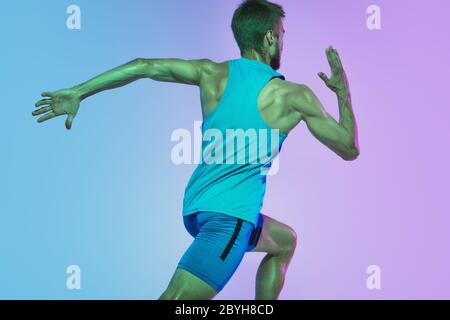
top-left (199, 61), bottom-right (301, 133)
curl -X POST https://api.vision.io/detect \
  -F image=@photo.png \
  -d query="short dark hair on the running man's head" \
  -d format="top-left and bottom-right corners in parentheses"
top-left (231, 0), bottom-right (285, 55)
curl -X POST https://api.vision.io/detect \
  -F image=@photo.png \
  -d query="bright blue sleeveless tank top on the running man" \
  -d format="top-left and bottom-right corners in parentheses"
top-left (183, 58), bottom-right (287, 226)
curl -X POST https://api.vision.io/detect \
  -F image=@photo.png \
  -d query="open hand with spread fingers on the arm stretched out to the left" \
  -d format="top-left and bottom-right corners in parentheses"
top-left (31, 89), bottom-right (80, 130)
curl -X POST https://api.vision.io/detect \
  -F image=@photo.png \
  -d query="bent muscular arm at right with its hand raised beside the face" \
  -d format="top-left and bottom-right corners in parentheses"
top-left (287, 47), bottom-right (359, 161)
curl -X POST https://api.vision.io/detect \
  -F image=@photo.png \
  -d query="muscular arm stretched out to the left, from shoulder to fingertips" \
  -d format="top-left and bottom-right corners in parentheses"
top-left (32, 59), bottom-right (213, 129)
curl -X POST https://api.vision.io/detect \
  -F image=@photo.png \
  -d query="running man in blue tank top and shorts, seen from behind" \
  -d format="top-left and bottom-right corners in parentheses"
top-left (32, 0), bottom-right (359, 299)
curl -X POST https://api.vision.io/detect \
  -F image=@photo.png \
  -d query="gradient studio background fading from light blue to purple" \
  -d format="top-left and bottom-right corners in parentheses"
top-left (0, 0), bottom-right (450, 299)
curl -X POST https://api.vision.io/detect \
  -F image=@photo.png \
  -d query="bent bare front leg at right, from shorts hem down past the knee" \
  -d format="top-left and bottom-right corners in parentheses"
top-left (252, 215), bottom-right (297, 300)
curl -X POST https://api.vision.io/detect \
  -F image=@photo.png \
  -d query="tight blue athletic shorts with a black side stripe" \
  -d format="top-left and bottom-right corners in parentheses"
top-left (177, 211), bottom-right (264, 292)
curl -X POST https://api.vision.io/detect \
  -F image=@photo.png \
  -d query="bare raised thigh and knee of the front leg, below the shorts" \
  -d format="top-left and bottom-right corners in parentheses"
top-left (251, 213), bottom-right (296, 255)
